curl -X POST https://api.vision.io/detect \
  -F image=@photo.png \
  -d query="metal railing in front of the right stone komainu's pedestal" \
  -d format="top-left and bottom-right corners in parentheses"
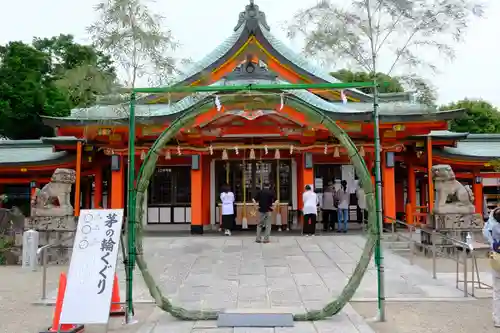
top-left (384, 216), bottom-right (491, 297)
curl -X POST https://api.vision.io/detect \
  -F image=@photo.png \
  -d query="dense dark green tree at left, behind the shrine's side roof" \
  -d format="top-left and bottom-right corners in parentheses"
top-left (0, 35), bottom-right (115, 139)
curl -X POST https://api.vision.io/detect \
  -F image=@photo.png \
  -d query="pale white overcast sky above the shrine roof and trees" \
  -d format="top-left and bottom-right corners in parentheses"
top-left (0, 0), bottom-right (500, 107)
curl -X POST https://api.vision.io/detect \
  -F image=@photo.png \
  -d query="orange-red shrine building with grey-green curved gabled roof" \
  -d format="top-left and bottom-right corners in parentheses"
top-left (0, 4), bottom-right (500, 234)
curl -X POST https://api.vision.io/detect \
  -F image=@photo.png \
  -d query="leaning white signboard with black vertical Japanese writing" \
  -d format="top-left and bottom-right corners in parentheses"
top-left (60, 209), bottom-right (123, 324)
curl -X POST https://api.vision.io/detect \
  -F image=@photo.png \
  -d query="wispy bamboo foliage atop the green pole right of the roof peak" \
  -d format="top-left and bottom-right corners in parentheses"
top-left (287, 0), bottom-right (484, 104)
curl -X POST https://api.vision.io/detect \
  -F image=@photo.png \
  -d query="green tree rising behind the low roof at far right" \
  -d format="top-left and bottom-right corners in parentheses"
top-left (440, 99), bottom-right (500, 133)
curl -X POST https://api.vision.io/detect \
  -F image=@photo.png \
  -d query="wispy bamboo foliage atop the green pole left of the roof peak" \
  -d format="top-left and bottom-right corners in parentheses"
top-left (87, 0), bottom-right (178, 88)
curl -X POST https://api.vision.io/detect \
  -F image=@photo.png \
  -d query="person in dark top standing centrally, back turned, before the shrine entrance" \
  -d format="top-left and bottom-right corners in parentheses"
top-left (252, 182), bottom-right (278, 243)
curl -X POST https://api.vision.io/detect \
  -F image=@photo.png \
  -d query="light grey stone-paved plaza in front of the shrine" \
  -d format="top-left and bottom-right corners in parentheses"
top-left (37, 233), bottom-right (474, 333)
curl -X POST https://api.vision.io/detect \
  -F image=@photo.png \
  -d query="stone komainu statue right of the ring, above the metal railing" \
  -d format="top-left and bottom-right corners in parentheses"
top-left (432, 164), bottom-right (475, 214)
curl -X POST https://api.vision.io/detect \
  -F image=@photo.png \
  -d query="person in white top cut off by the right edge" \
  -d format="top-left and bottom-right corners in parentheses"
top-left (483, 208), bottom-right (500, 327)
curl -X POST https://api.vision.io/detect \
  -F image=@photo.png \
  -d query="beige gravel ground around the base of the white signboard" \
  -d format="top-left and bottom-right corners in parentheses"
top-left (0, 266), bottom-right (154, 333)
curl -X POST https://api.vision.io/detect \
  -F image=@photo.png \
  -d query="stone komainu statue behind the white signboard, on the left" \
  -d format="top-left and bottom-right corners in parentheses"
top-left (31, 169), bottom-right (76, 217)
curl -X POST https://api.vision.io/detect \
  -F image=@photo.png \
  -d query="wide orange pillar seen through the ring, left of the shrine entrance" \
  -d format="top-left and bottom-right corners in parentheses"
top-left (191, 155), bottom-right (203, 235)
